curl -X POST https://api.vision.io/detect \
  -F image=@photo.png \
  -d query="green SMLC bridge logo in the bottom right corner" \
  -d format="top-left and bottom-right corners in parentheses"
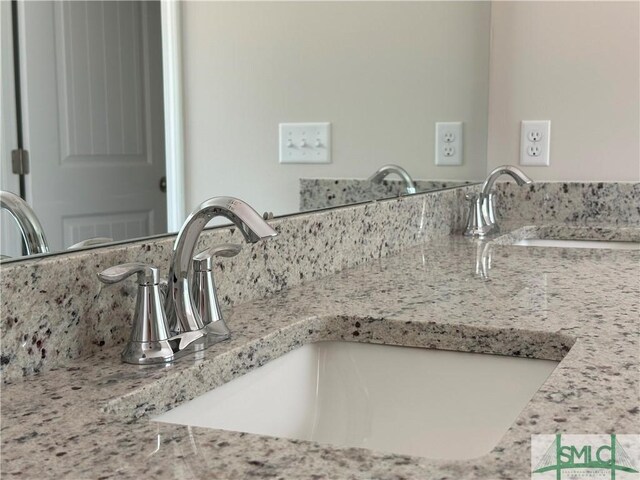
top-left (532, 434), bottom-right (638, 480)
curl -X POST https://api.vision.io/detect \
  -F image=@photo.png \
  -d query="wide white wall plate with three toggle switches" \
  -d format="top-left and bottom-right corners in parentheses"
top-left (279, 122), bottom-right (331, 163)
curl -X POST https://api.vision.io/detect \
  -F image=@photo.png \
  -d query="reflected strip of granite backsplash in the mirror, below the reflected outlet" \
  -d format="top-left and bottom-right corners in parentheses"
top-left (300, 178), bottom-right (473, 212)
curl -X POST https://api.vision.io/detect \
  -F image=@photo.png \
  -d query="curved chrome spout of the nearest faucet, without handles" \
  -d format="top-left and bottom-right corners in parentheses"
top-left (165, 197), bottom-right (278, 335)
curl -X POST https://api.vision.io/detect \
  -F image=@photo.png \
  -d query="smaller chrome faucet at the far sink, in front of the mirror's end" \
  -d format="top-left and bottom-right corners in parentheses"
top-left (464, 165), bottom-right (533, 237)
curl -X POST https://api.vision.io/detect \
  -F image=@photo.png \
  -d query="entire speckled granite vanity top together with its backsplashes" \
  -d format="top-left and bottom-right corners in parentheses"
top-left (0, 183), bottom-right (640, 479)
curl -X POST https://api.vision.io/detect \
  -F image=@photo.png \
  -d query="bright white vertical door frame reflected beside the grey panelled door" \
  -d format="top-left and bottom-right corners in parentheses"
top-left (160, 0), bottom-right (186, 232)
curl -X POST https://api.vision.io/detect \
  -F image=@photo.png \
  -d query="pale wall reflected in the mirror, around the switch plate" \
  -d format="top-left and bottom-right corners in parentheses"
top-left (182, 2), bottom-right (491, 214)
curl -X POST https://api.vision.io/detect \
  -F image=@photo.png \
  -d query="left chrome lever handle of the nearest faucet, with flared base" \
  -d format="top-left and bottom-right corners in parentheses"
top-left (98, 262), bottom-right (174, 365)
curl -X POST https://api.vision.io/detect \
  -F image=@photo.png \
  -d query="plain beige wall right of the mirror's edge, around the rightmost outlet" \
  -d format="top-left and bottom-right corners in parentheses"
top-left (488, 1), bottom-right (640, 181)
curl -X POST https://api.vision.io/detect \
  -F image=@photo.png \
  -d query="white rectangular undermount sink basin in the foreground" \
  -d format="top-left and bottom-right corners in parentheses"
top-left (153, 342), bottom-right (558, 459)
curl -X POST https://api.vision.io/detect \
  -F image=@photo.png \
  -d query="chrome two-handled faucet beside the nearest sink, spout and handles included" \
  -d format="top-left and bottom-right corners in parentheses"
top-left (98, 197), bottom-right (277, 364)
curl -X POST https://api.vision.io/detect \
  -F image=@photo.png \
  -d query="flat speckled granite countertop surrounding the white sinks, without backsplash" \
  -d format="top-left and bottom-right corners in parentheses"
top-left (1, 229), bottom-right (640, 479)
